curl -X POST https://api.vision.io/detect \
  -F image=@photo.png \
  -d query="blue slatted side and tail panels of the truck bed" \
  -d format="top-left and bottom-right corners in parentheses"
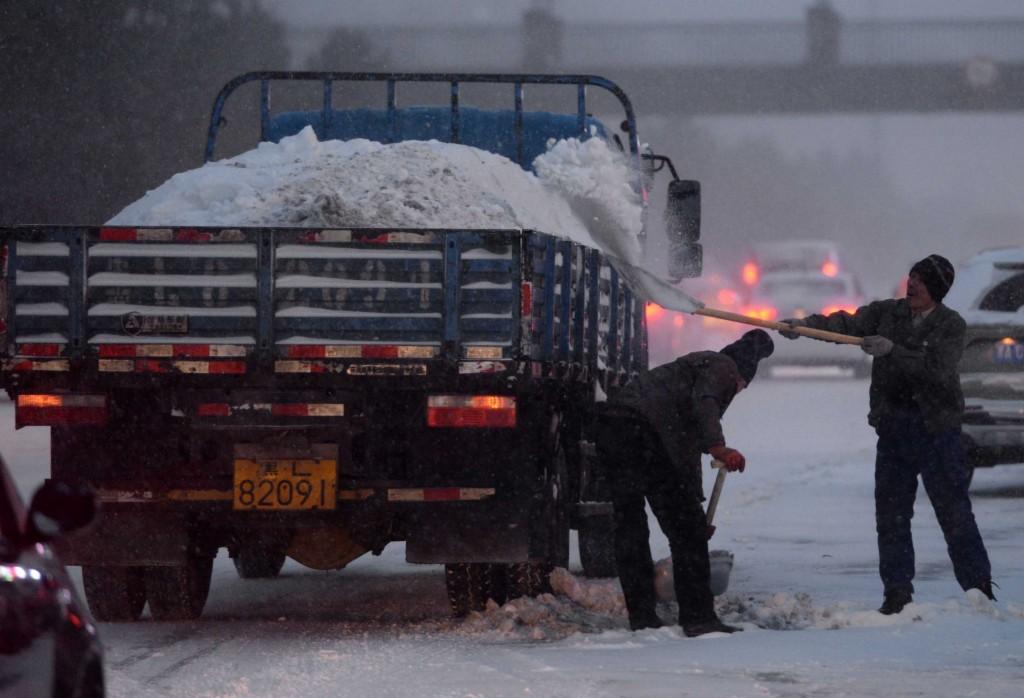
top-left (0, 226), bottom-right (644, 375)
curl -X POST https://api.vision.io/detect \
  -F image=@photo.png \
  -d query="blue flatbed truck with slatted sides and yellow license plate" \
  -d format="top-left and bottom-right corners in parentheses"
top-left (0, 72), bottom-right (700, 620)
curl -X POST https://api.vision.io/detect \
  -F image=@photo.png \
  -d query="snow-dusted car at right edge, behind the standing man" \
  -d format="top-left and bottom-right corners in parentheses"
top-left (943, 247), bottom-right (1024, 468)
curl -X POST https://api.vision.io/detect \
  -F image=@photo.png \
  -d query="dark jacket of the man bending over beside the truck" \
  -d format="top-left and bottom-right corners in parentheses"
top-left (608, 351), bottom-right (739, 476)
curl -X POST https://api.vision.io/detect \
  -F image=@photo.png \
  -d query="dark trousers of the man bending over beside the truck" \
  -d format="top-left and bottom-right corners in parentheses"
top-left (597, 416), bottom-right (715, 624)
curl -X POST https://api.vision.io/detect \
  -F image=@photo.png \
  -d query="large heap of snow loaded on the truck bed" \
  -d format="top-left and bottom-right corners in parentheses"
top-left (109, 127), bottom-right (641, 263)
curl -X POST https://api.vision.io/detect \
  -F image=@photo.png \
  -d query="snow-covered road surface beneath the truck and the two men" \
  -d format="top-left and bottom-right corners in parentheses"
top-left (0, 378), bottom-right (1024, 698)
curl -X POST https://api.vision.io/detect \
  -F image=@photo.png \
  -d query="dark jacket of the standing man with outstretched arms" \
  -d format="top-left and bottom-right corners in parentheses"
top-left (798, 299), bottom-right (966, 432)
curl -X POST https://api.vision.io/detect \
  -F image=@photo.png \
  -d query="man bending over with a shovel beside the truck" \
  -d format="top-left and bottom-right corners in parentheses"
top-left (597, 330), bottom-right (774, 637)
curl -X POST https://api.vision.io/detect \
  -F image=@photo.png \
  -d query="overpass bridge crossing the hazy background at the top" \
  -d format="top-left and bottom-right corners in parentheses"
top-left (293, 12), bottom-right (1024, 115)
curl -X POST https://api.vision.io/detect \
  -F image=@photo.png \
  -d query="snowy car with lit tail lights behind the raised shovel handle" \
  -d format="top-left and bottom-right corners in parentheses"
top-left (742, 271), bottom-right (871, 378)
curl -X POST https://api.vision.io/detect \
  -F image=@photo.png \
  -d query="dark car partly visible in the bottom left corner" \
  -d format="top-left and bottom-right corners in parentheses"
top-left (0, 457), bottom-right (104, 698)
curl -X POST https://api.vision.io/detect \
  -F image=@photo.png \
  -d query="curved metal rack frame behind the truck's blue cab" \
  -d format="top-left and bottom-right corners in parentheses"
top-left (203, 71), bottom-right (640, 171)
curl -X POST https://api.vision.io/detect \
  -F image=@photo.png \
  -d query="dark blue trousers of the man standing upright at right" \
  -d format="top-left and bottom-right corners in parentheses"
top-left (874, 413), bottom-right (991, 593)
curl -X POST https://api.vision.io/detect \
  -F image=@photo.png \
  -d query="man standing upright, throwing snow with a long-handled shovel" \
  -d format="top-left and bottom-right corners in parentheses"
top-left (782, 255), bottom-right (995, 615)
